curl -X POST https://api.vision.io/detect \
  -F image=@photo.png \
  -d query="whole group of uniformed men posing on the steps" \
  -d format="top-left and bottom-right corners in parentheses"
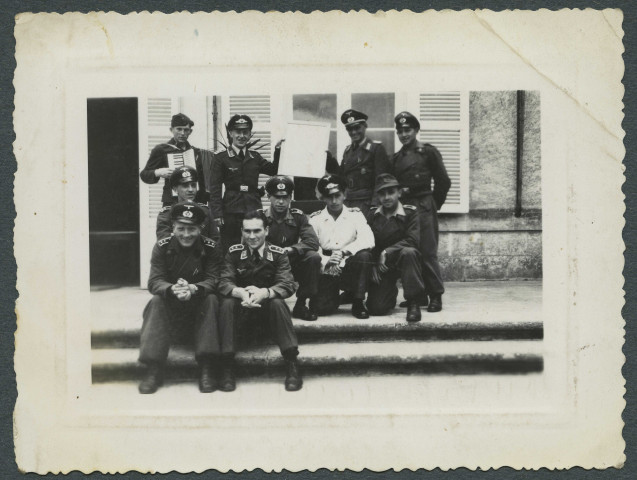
top-left (139, 109), bottom-right (451, 393)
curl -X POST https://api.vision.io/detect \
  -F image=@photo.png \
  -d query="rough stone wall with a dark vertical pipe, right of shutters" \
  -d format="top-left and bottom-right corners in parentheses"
top-left (438, 91), bottom-right (542, 281)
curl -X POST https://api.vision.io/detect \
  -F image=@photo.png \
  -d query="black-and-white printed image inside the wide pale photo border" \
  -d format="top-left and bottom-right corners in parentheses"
top-left (86, 89), bottom-right (543, 395)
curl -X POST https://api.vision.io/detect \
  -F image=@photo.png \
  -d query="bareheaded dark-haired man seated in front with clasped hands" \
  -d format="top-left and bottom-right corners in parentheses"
top-left (219, 211), bottom-right (303, 391)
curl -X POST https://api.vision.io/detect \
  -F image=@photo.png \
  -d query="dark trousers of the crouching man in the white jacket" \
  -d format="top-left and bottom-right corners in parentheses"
top-left (310, 250), bottom-right (373, 315)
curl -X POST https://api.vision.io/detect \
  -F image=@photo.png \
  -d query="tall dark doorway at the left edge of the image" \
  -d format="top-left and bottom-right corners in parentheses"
top-left (87, 98), bottom-right (139, 286)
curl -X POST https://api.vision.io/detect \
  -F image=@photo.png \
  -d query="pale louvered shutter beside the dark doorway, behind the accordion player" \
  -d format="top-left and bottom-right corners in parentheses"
top-left (138, 97), bottom-right (178, 288)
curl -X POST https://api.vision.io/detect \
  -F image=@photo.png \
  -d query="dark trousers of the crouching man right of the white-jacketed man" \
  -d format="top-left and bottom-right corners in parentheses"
top-left (367, 247), bottom-right (425, 315)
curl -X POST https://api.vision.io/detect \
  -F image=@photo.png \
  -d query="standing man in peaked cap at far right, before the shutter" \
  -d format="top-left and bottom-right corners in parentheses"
top-left (391, 112), bottom-right (451, 312)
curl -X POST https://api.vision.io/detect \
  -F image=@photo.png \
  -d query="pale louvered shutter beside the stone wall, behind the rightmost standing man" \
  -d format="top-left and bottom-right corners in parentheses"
top-left (419, 92), bottom-right (469, 213)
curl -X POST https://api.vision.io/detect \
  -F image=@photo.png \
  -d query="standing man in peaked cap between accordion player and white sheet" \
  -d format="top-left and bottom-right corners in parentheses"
top-left (206, 115), bottom-right (279, 248)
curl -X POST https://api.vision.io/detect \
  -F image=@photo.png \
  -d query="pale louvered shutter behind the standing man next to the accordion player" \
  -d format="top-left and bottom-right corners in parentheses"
top-left (226, 95), bottom-right (274, 208)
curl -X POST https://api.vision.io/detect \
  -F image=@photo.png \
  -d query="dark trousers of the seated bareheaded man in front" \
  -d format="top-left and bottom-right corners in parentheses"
top-left (219, 297), bottom-right (299, 358)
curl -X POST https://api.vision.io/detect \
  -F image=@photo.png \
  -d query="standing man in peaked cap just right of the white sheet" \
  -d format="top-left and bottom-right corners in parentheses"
top-left (340, 109), bottom-right (389, 215)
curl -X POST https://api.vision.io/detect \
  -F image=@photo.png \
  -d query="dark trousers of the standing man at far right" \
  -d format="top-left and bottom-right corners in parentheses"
top-left (401, 195), bottom-right (445, 295)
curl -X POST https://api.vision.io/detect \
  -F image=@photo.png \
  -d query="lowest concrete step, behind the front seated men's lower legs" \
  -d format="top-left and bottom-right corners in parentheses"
top-left (92, 340), bottom-right (543, 382)
